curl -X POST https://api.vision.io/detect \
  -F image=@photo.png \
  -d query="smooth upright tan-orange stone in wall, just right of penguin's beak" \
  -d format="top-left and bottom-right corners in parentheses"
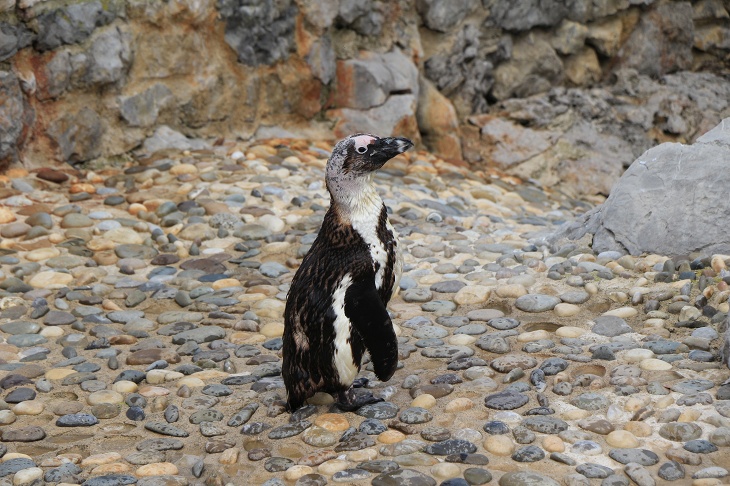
top-left (416, 77), bottom-right (462, 160)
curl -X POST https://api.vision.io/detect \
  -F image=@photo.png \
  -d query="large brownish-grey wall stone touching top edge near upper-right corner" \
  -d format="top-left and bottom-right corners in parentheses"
top-left (617, 2), bottom-right (694, 76)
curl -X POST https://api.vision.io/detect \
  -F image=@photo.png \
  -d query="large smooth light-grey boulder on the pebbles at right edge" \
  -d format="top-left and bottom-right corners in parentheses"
top-left (551, 118), bottom-right (730, 256)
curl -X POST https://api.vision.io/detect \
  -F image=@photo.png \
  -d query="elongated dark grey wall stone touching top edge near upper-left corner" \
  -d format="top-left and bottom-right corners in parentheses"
top-left (35, 0), bottom-right (124, 51)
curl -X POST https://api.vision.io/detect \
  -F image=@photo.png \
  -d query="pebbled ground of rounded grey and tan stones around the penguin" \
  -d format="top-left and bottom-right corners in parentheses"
top-left (0, 141), bottom-right (730, 486)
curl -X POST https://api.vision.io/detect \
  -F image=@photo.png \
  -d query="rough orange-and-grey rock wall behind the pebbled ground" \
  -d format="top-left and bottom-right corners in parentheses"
top-left (0, 0), bottom-right (730, 193)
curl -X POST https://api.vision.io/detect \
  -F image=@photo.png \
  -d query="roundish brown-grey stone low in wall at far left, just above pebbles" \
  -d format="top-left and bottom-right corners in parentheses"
top-left (48, 107), bottom-right (106, 164)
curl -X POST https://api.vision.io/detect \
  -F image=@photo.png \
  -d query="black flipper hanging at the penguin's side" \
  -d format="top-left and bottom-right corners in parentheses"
top-left (345, 278), bottom-right (398, 381)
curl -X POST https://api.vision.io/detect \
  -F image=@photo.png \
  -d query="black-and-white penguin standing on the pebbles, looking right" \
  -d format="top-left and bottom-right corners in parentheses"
top-left (282, 133), bottom-right (413, 412)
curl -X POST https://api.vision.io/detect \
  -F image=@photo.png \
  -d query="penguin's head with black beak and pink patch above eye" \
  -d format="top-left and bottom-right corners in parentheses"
top-left (326, 133), bottom-right (413, 193)
